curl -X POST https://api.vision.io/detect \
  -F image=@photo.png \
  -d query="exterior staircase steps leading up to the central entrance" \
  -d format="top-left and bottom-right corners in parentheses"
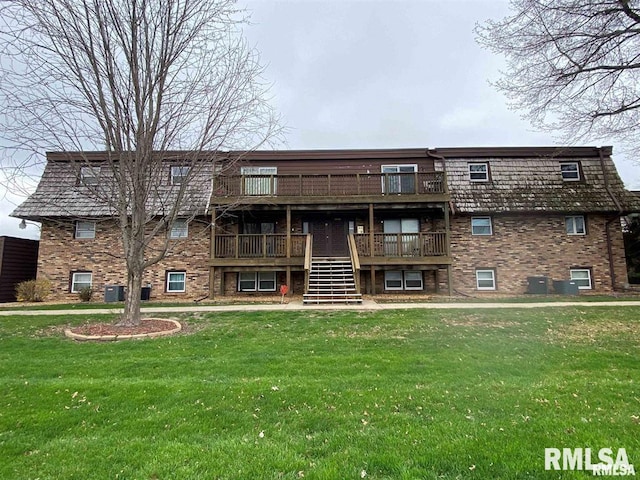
top-left (302, 257), bottom-right (362, 304)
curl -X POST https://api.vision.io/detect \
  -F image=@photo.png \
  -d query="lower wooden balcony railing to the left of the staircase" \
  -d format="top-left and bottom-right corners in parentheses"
top-left (214, 234), bottom-right (307, 258)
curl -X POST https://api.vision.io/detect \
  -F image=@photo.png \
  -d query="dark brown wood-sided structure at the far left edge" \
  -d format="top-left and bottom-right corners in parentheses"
top-left (0, 237), bottom-right (39, 302)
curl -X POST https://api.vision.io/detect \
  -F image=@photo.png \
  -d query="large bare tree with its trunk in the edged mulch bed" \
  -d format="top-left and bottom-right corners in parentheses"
top-left (0, 0), bottom-right (278, 324)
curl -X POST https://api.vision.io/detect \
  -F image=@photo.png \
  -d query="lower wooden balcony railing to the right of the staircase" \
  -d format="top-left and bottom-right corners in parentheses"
top-left (354, 232), bottom-right (448, 257)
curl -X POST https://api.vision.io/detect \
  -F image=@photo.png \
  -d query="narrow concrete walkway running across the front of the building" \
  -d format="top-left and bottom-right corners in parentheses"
top-left (0, 300), bottom-right (640, 316)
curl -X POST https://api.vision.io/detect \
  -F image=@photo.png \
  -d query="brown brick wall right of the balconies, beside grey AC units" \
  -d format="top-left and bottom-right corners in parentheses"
top-left (451, 215), bottom-right (627, 295)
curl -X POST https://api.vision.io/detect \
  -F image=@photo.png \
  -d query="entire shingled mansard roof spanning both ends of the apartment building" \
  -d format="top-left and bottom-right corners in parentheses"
top-left (12, 147), bottom-right (640, 220)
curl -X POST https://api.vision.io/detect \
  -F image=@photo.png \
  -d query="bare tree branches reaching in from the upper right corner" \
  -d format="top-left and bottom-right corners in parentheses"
top-left (476, 0), bottom-right (640, 148)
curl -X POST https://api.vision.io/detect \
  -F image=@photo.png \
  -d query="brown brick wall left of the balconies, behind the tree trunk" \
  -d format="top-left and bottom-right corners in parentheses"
top-left (38, 219), bottom-right (209, 301)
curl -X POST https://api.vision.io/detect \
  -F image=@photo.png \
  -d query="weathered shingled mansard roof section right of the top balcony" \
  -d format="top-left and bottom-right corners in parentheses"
top-left (438, 147), bottom-right (640, 213)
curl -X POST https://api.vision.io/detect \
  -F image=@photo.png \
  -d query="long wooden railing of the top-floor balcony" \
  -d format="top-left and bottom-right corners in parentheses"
top-left (213, 172), bottom-right (446, 197)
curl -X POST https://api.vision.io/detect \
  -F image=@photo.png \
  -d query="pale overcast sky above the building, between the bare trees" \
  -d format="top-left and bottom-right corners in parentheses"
top-left (0, 0), bottom-right (640, 238)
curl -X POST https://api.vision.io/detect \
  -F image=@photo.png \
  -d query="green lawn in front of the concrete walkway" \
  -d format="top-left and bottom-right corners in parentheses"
top-left (0, 306), bottom-right (640, 479)
